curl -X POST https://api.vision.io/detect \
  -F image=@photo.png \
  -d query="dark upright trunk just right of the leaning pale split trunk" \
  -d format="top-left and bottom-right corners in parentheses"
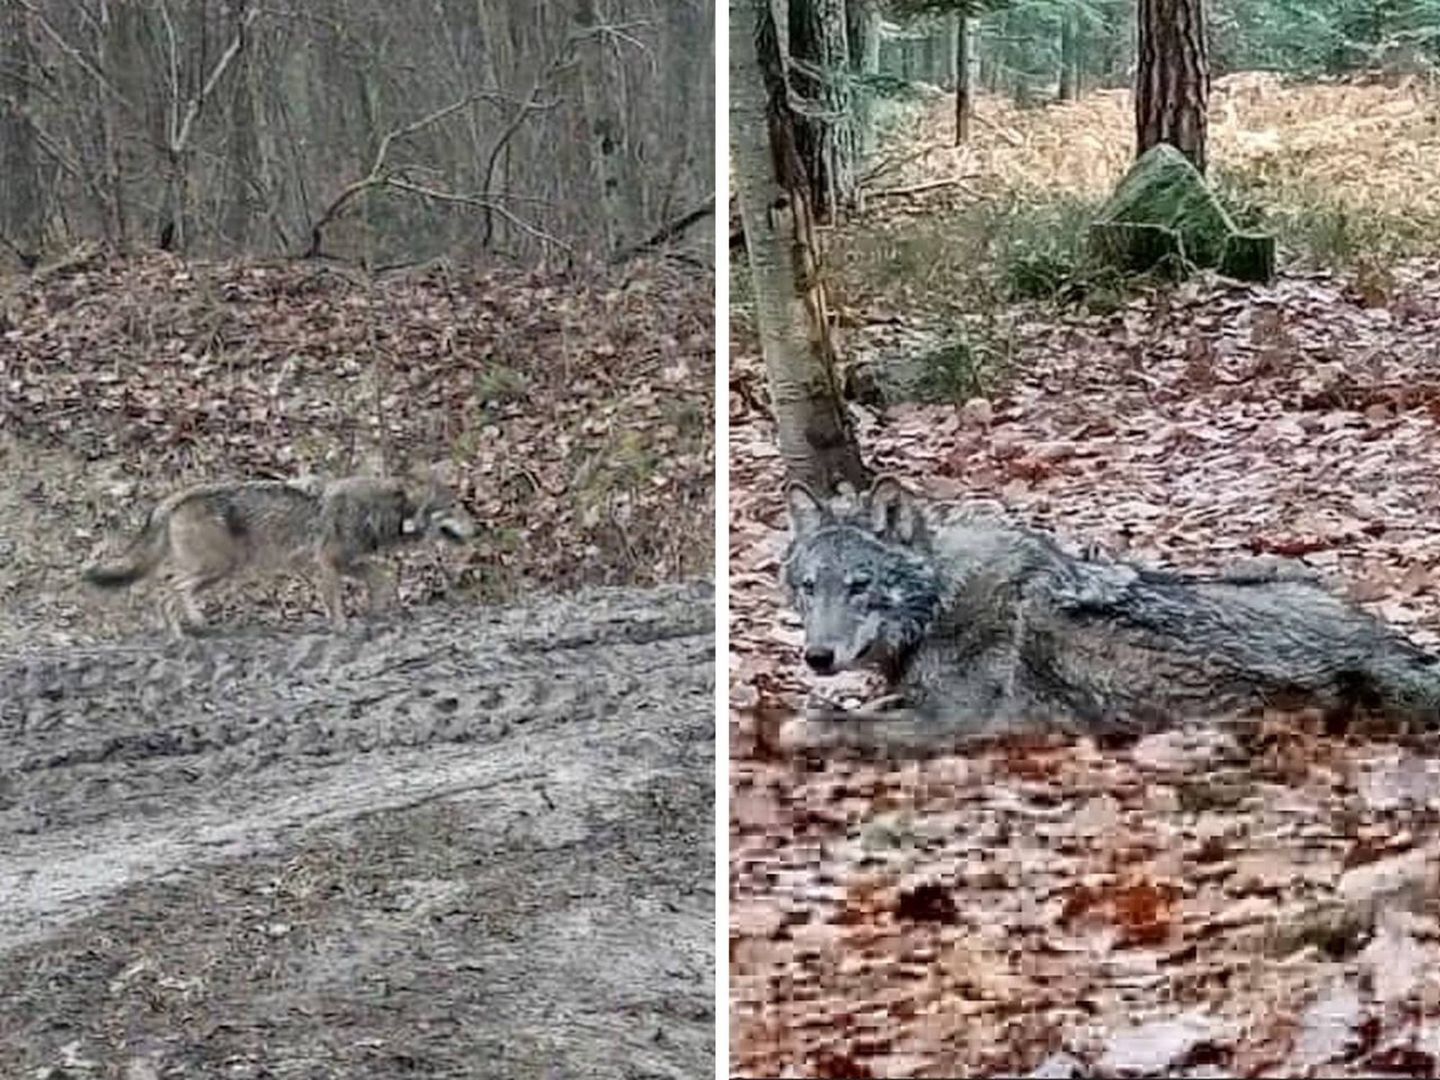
top-left (780, 0), bottom-right (855, 222)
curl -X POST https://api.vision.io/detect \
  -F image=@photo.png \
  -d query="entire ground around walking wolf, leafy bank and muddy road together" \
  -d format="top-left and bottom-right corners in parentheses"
top-left (0, 249), bottom-right (714, 1080)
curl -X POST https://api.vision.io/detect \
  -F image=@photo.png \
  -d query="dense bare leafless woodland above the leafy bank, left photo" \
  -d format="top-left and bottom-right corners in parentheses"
top-left (0, 0), bottom-right (714, 262)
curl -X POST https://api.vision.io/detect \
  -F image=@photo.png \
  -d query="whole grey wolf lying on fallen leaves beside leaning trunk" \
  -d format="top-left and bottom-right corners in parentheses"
top-left (782, 480), bottom-right (1440, 746)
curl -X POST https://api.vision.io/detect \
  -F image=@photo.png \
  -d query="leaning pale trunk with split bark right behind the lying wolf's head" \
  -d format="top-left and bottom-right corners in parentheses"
top-left (730, 0), bottom-right (865, 491)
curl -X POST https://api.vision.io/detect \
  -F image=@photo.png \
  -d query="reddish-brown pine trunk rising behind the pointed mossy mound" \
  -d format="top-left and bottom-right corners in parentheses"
top-left (1135, 0), bottom-right (1210, 173)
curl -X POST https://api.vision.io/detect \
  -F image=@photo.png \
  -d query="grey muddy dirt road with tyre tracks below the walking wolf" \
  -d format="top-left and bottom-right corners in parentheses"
top-left (0, 586), bottom-right (714, 1080)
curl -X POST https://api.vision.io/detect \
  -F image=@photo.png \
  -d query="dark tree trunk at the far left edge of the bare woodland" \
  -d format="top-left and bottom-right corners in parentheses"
top-left (0, 0), bottom-right (45, 264)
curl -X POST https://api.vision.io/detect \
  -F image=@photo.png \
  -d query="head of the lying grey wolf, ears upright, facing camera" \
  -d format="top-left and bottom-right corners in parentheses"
top-left (782, 478), bottom-right (940, 675)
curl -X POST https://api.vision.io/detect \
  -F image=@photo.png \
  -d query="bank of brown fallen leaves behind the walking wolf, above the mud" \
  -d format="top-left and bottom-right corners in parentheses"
top-left (0, 251), bottom-right (714, 644)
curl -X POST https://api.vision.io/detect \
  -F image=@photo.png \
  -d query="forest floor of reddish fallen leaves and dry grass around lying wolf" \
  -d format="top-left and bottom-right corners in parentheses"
top-left (729, 79), bottom-right (1440, 1077)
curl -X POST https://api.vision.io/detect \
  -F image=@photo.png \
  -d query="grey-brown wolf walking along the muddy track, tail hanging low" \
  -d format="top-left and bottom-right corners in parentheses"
top-left (84, 477), bottom-right (474, 636)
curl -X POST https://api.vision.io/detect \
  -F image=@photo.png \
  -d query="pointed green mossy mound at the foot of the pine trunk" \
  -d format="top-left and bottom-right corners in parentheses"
top-left (1090, 143), bottom-right (1274, 288)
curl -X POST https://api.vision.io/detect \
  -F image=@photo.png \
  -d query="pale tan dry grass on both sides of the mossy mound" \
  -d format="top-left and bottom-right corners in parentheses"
top-left (828, 72), bottom-right (1440, 324)
